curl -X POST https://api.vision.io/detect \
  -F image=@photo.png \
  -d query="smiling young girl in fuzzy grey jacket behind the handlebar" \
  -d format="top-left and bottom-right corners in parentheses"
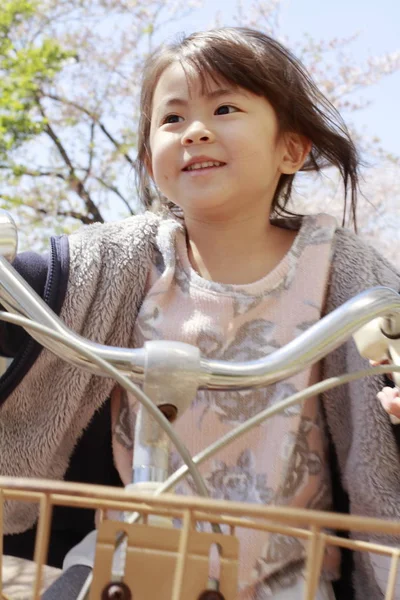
top-left (0, 28), bottom-right (400, 599)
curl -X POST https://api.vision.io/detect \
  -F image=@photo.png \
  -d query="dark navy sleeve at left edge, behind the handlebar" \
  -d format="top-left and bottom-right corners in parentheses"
top-left (0, 252), bottom-right (49, 358)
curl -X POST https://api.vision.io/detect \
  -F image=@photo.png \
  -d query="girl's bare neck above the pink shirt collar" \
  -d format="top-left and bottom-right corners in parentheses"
top-left (185, 215), bottom-right (296, 284)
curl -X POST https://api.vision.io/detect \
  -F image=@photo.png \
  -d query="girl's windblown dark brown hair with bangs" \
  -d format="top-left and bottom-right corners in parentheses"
top-left (137, 27), bottom-right (358, 225)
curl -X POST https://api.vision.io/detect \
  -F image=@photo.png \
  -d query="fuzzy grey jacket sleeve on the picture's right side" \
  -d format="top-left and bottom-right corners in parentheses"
top-left (322, 230), bottom-right (400, 600)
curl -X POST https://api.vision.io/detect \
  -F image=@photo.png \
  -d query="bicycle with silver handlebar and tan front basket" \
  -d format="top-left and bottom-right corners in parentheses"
top-left (0, 207), bottom-right (400, 600)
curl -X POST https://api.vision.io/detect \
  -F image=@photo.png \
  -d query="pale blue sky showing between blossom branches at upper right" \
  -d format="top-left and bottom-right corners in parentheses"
top-left (158, 0), bottom-right (400, 156)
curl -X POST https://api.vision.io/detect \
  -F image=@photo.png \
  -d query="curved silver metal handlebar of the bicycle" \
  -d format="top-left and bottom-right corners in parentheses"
top-left (0, 211), bottom-right (400, 390)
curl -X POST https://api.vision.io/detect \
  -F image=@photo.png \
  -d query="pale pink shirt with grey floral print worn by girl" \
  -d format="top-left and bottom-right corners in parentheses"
top-left (114, 215), bottom-right (338, 591)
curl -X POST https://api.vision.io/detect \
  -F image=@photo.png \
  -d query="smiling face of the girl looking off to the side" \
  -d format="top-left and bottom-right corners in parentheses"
top-left (149, 63), bottom-right (287, 219)
